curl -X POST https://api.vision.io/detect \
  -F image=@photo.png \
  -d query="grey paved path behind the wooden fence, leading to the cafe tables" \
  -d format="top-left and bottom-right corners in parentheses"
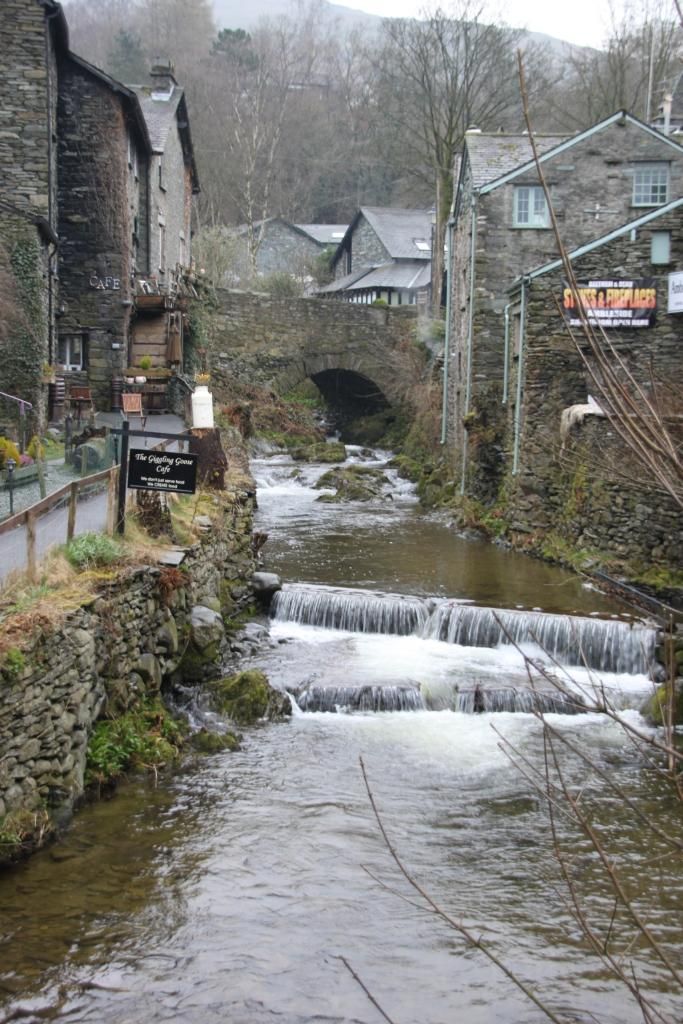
top-left (0, 413), bottom-right (186, 584)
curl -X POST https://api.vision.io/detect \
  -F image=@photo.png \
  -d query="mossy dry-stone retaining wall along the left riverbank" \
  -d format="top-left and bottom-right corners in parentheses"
top-left (0, 490), bottom-right (256, 863)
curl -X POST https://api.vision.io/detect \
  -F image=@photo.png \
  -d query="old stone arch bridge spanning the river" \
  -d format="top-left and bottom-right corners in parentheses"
top-left (209, 291), bottom-right (420, 407)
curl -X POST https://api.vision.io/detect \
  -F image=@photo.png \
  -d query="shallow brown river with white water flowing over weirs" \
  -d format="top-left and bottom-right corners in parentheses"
top-left (0, 454), bottom-right (683, 1024)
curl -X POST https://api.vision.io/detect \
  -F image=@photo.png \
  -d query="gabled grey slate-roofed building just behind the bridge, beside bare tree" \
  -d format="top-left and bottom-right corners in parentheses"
top-left (317, 206), bottom-right (432, 306)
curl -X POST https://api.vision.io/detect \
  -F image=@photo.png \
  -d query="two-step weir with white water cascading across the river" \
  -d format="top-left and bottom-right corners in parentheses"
top-left (271, 584), bottom-right (656, 715)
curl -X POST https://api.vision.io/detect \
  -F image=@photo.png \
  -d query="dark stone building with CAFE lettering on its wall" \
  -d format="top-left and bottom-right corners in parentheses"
top-left (55, 53), bottom-right (151, 409)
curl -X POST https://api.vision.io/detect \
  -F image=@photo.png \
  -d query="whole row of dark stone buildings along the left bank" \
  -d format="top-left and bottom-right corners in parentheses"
top-left (0, 0), bottom-right (199, 425)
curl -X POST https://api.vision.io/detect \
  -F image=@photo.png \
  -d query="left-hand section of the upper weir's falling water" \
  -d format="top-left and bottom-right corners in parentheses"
top-left (270, 587), bottom-right (429, 636)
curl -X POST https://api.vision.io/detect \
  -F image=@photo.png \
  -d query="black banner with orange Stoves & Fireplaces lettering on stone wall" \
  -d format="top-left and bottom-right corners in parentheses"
top-left (562, 278), bottom-right (657, 328)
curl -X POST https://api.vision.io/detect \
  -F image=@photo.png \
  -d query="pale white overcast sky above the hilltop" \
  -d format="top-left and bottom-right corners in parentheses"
top-left (338, 0), bottom-right (634, 46)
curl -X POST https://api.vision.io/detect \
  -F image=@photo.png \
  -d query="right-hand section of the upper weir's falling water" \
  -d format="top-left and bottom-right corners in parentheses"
top-left (422, 601), bottom-right (656, 674)
